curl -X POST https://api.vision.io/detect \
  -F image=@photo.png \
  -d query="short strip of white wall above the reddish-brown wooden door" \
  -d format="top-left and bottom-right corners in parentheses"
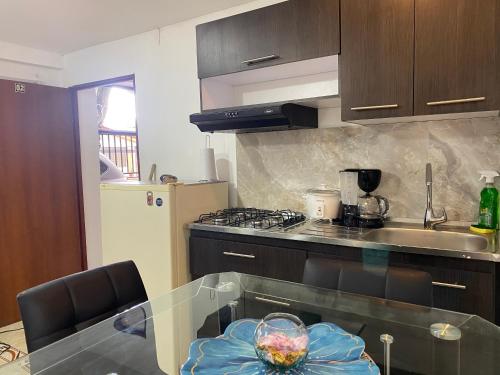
top-left (0, 41), bottom-right (63, 86)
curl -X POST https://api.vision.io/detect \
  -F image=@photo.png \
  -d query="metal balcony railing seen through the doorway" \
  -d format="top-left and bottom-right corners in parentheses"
top-left (99, 130), bottom-right (139, 180)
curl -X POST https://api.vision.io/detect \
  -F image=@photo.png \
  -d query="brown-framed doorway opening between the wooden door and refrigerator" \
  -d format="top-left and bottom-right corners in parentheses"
top-left (71, 75), bottom-right (141, 269)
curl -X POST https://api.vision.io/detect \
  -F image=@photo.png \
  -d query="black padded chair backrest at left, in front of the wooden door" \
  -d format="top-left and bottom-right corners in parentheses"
top-left (17, 261), bottom-right (148, 352)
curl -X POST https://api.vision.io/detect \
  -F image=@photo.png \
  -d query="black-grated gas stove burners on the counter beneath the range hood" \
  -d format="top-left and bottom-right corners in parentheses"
top-left (196, 208), bottom-right (306, 229)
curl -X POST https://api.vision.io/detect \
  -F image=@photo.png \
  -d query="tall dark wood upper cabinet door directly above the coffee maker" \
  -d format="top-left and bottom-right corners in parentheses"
top-left (340, 0), bottom-right (414, 121)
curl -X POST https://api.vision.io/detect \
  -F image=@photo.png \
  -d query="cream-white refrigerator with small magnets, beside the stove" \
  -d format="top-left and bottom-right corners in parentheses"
top-left (101, 182), bottom-right (228, 299)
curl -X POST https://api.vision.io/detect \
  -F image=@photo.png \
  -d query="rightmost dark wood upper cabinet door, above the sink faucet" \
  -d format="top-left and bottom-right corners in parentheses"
top-left (415, 0), bottom-right (498, 115)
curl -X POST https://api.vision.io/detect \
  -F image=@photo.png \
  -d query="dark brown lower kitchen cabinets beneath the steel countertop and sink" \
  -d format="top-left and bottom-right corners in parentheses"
top-left (190, 231), bottom-right (500, 324)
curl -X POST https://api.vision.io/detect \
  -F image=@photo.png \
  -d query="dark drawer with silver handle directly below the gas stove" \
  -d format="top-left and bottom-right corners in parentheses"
top-left (190, 237), bottom-right (306, 282)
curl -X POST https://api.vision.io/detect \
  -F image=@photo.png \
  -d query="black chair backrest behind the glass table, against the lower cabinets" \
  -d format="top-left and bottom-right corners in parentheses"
top-left (302, 256), bottom-right (432, 306)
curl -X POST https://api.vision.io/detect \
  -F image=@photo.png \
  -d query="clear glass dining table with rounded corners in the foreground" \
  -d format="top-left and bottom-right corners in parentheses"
top-left (0, 272), bottom-right (500, 375)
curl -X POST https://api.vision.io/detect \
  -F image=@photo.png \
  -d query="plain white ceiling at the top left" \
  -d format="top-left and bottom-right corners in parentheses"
top-left (0, 0), bottom-right (251, 54)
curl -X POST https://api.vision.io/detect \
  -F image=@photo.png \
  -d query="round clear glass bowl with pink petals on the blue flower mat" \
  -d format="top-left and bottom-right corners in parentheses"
top-left (254, 313), bottom-right (309, 370)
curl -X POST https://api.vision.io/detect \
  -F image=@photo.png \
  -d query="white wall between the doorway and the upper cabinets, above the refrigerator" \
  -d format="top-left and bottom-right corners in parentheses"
top-left (64, 0), bottom-right (282, 203)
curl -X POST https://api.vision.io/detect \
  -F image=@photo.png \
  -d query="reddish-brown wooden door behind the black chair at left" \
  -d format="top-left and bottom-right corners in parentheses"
top-left (0, 80), bottom-right (83, 327)
